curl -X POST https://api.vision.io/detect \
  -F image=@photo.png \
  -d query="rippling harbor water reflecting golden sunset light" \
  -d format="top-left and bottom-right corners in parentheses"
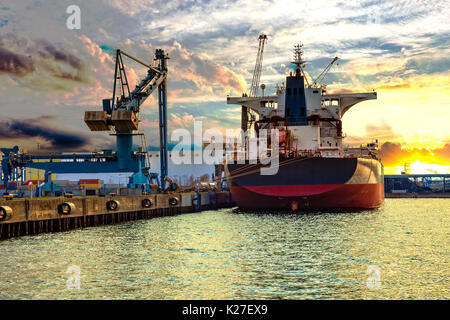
top-left (0, 199), bottom-right (450, 299)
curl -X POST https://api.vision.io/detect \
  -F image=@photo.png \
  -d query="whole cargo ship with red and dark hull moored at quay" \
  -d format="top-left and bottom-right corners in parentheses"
top-left (224, 44), bottom-right (384, 210)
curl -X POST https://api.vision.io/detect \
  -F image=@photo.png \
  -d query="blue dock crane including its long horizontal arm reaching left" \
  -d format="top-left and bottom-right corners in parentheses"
top-left (0, 49), bottom-right (169, 190)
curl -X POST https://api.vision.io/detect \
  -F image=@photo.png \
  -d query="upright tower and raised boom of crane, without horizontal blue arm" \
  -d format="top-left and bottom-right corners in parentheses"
top-left (84, 49), bottom-right (169, 190)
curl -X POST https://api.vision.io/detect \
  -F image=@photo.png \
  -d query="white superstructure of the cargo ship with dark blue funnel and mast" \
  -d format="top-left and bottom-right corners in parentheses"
top-left (227, 45), bottom-right (377, 157)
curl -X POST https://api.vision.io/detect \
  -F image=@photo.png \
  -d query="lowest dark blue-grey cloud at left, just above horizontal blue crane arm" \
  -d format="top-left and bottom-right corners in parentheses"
top-left (0, 117), bottom-right (89, 151)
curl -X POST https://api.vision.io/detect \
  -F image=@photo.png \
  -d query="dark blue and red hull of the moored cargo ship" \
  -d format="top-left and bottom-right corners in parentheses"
top-left (225, 158), bottom-right (384, 211)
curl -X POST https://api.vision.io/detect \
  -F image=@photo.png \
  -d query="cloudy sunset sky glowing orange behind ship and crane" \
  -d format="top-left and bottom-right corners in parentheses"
top-left (0, 0), bottom-right (450, 172)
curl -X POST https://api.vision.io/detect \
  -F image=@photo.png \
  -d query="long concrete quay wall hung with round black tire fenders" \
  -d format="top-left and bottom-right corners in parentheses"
top-left (0, 191), bottom-right (233, 239)
